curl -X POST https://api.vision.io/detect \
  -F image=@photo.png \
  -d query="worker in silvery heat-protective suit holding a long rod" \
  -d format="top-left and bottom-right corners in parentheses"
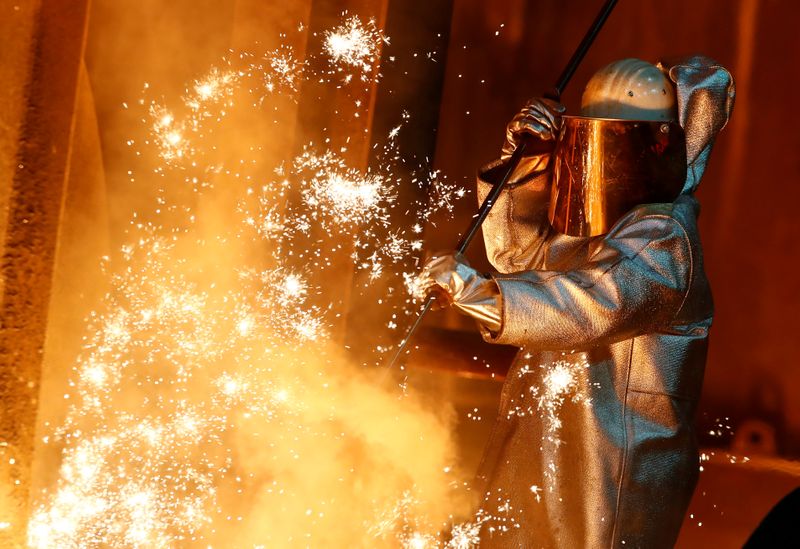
top-left (418, 56), bottom-right (734, 548)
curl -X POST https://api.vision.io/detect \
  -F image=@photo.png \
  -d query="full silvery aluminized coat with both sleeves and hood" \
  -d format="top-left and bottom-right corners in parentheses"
top-left (478, 57), bottom-right (733, 548)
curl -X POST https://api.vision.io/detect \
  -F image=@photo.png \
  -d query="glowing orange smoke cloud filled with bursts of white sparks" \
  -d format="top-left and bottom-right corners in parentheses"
top-left (29, 5), bottom-right (476, 547)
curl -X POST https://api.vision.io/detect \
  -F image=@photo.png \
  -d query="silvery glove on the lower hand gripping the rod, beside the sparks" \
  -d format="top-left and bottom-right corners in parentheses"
top-left (415, 253), bottom-right (502, 332)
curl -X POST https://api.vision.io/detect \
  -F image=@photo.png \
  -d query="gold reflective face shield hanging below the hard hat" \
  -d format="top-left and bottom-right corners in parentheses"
top-left (549, 116), bottom-right (686, 236)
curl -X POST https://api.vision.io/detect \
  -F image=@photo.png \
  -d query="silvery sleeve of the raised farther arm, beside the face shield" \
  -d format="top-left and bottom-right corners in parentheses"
top-left (477, 155), bottom-right (551, 273)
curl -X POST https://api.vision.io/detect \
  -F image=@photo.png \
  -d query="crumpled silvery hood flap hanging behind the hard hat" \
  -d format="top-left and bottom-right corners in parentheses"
top-left (668, 55), bottom-right (736, 194)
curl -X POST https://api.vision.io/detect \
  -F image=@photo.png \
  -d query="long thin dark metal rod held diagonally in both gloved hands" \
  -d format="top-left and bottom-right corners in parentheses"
top-left (388, 0), bottom-right (617, 369)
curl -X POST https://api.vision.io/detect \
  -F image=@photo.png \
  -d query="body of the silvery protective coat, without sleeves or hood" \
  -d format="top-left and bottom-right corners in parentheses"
top-left (480, 197), bottom-right (713, 547)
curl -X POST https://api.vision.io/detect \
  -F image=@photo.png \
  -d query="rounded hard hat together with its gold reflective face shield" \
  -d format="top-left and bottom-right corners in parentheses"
top-left (549, 59), bottom-right (686, 236)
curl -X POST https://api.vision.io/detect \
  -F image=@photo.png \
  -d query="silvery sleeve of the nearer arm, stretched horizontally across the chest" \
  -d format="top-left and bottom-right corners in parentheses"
top-left (483, 215), bottom-right (692, 350)
